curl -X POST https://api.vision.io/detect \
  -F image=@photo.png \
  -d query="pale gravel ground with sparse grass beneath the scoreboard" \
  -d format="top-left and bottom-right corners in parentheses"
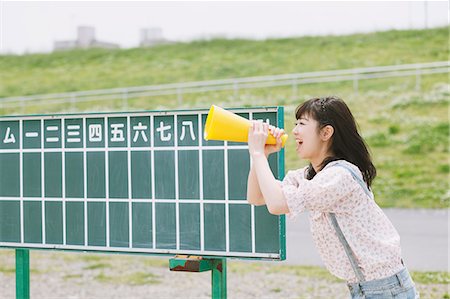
top-left (0, 250), bottom-right (450, 299)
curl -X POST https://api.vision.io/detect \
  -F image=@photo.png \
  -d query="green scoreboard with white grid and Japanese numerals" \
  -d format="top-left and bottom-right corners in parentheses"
top-left (0, 107), bottom-right (286, 260)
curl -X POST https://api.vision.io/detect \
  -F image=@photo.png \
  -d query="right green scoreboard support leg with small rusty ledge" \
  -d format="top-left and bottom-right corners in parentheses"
top-left (169, 255), bottom-right (227, 299)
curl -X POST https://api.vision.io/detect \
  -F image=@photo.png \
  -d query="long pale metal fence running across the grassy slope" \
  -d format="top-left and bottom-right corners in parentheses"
top-left (0, 61), bottom-right (450, 113)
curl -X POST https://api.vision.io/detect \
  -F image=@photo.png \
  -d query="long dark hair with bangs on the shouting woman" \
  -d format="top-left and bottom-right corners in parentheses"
top-left (295, 96), bottom-right (377, 187)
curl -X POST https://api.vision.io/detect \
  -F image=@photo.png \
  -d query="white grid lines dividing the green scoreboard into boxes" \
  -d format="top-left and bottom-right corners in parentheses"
top-left (0, 108), bottom-right (280, 258)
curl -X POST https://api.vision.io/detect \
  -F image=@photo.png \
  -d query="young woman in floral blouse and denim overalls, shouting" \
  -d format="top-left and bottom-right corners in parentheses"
top-left (247, 97), bottom-right (419, 299)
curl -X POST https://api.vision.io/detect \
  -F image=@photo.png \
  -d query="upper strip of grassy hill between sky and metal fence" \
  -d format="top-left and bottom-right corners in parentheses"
top-left (0, 27), bottom-right (449, 97)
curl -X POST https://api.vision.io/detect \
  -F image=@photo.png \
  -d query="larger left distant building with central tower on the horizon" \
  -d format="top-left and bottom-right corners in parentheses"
top-left (53, 26), bottom-right (119, 51)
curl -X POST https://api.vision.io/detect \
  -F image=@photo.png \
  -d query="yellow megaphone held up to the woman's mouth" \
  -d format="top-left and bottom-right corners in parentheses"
top-left (203, 105), bottom-right (288, 147)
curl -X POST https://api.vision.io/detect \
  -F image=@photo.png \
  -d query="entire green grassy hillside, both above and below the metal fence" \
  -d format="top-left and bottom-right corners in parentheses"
top-left (0, 27), bottom-right (450, 208)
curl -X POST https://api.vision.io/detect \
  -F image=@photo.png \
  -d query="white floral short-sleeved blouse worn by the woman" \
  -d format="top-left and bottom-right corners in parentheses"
top-left (281, 160), bottom-right (403, 283)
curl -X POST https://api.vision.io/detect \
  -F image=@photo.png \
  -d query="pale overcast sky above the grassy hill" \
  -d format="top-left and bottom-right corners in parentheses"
top-left (0, 0), bottom-right (449, 54)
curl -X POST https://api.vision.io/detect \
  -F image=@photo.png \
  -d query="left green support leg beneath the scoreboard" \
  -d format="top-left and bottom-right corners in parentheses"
top-left (16, 249), bottom-right (30, 299)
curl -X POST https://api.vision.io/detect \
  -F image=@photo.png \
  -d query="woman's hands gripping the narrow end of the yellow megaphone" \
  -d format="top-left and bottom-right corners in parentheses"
top-left (248, 120), bottom-right (284, 157)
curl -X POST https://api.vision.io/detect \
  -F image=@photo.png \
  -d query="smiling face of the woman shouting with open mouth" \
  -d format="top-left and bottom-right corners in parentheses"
top-left (292, 115), bottom-right (324, 160)
